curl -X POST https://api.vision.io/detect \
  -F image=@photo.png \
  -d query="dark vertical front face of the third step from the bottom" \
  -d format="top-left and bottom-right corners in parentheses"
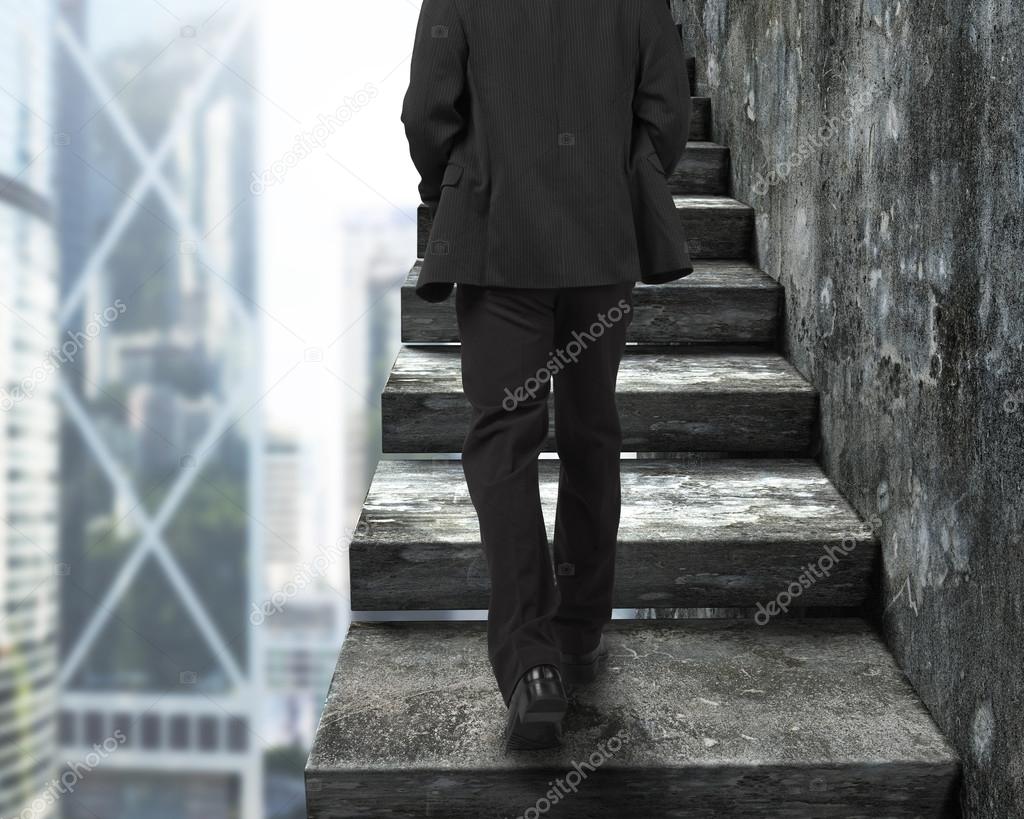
top-left (381, 391), bottom-right (817, 454)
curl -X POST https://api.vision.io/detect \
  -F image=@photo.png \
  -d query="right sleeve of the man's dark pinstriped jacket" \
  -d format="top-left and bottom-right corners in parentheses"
top-left (633, 0), bottom-right (692, 174)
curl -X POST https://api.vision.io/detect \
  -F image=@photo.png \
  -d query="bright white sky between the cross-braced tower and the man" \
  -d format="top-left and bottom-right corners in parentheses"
top-left (257, 0), bottom-right (420, 424)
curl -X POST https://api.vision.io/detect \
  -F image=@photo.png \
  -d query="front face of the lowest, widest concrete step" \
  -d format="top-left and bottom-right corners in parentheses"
top-left (306, 769), bottom-right (958, 819)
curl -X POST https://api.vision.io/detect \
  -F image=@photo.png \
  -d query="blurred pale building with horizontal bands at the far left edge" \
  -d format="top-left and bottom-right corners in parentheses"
top-left (0, 0), bottom-right (61, 819)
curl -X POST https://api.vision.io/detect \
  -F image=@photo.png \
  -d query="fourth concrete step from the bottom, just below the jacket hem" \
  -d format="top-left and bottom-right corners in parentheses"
top-left (401, 261), bottom-right (782, 345)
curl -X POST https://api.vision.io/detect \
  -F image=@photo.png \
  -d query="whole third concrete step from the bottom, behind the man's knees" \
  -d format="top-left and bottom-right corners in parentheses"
top-left (381, 347), bottom-right (817, 455)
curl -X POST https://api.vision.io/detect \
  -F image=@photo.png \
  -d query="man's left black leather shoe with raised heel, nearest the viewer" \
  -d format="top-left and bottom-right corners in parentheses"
top-left (505, 665), bottom-right (568, 751)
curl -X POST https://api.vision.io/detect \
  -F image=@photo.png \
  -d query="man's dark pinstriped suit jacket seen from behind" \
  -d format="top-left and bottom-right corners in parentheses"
top-left (401, 0), bottom-right (693, 301)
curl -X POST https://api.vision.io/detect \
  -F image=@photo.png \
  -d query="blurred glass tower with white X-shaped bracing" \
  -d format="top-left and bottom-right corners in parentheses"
top-left (55, 0), bottom-right (266, 819)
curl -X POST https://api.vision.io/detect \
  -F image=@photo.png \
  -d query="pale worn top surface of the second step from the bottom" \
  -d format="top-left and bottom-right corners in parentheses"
top-left (360, 458), bottom-right (876, 549)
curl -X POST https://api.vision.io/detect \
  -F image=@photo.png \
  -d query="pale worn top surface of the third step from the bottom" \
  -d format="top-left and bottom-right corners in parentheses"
top-left (385, 346), bottom-right (815, 396)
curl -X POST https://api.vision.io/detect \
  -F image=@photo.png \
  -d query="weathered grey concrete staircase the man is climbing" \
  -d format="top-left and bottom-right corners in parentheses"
top-left (306, 59), bottom-right (959, 819)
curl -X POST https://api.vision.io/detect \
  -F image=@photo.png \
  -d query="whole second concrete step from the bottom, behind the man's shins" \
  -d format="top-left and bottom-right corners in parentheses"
top-left (349, 459), bottom-right (879, 617)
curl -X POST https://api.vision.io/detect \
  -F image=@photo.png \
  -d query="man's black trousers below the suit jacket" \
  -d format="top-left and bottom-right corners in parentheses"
top-left (456, 282), bottom-right (634, 705)
